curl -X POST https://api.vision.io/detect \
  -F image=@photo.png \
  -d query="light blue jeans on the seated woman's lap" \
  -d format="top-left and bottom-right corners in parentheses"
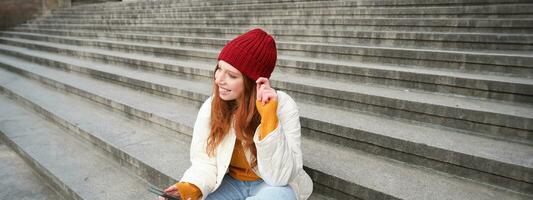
top-left (206, 174), bottom-right (296, 200)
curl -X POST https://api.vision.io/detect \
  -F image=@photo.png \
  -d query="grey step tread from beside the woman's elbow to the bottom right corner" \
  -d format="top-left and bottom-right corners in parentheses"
top-left (302, 140), bottom-right (531, 199)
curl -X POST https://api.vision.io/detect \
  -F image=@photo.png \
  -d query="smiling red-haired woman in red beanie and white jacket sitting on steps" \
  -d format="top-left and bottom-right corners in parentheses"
top-left (160, 29), bottom-right (313, 200)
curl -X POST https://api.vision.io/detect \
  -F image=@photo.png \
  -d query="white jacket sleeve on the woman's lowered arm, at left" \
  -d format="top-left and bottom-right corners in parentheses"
top-left (180, 97), bottom-right (217, 198)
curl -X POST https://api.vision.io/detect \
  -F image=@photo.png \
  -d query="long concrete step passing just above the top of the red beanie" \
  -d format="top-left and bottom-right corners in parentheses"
top-left (19, 18), bottom-right (533, 34)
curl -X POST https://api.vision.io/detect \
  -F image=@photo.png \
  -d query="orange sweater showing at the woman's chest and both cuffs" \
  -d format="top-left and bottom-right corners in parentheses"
top-left (176, 100), bottom-right (278, 200)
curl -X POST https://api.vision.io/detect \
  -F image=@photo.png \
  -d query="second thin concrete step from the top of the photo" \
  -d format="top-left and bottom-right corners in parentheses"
top-left (45, 3), bottom-right (533, 17)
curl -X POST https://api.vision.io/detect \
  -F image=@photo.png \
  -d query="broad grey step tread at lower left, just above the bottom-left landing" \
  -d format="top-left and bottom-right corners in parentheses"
top-left (0, 95), bottom-right (154, 199)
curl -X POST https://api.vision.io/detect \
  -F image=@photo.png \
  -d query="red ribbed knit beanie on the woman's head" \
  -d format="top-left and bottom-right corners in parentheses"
top-left (218, 28), bottom-right (277, 81)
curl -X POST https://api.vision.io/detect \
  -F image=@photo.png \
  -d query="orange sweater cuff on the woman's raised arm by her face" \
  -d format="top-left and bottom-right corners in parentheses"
top-left (255, 100), bottom-right (278, 140)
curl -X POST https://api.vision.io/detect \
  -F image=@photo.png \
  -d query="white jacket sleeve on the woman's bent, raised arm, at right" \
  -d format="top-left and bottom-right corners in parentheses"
top-left (254, 92), bottom-right (303, 186)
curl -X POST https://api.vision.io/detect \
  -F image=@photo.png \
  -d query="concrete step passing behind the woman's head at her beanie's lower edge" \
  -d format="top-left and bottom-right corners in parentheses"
top-left (0, 39), bottom-right (533, 144)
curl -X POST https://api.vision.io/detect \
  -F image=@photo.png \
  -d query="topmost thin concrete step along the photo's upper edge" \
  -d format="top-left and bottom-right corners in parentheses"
top-left (53, 0), bottom-right (531, 14)
